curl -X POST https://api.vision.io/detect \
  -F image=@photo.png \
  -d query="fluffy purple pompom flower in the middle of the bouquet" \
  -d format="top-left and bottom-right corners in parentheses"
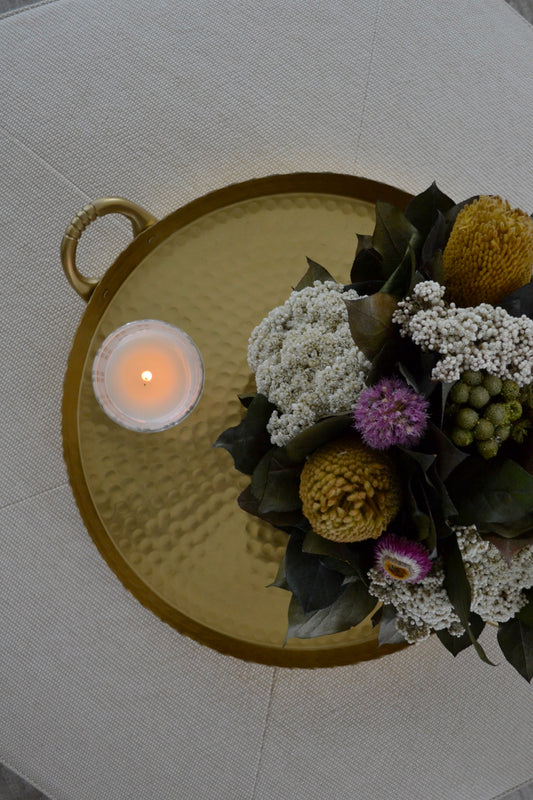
top-left (353, 378), bottom-right (429, 450)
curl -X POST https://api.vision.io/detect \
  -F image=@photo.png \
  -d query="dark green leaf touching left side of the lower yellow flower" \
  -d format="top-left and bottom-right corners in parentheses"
top-left (251, 447), bottom-right (302, 514)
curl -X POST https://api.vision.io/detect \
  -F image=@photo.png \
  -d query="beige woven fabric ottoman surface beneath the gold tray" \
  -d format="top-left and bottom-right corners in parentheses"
top-left (0, 0), bottom-right (533, 800)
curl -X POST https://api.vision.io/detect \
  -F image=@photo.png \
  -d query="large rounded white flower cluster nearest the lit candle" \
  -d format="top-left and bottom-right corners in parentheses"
top-left (248, 281), bottom-right (370, 447)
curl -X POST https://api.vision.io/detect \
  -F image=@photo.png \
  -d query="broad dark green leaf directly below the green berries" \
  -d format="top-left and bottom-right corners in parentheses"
top-left (449, 456), bottom-right (533, 539)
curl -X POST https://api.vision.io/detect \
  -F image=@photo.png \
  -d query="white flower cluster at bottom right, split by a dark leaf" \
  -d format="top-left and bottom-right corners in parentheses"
top-left (368, 525), bottom-right (533, 643)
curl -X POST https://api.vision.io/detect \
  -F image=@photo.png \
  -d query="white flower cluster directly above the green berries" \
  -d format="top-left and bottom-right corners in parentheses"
top-left (392, 281), bottom-right (533, 386)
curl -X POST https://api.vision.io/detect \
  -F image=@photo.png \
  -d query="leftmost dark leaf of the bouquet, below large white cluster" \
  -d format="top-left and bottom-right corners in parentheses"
top-left (213, 394), bottom-right (276, 475)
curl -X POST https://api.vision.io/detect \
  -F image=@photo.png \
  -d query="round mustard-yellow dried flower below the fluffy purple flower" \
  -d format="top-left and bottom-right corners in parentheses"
top-left (300, 436), bottom-right (401, 542)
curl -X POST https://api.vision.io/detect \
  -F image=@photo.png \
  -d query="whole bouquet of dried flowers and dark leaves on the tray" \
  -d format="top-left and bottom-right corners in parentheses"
top-left (215, 184), bottom-right (533, 681)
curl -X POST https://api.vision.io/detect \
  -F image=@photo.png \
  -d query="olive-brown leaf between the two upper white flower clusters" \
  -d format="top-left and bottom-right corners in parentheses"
top-left (345, 292), bottom-right (398, 359)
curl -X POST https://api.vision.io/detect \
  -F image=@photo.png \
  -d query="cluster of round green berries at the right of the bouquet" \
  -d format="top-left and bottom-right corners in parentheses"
top-left (446, 370), bottom-right (533, 459)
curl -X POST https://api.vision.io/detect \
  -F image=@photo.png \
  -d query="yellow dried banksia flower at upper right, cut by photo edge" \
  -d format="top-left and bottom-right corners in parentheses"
top-left (443, 195), bottom-right (533, 307)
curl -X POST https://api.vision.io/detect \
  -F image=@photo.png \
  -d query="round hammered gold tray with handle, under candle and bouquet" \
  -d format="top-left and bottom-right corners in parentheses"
top-left (62, 173), bottom-right (409, 667)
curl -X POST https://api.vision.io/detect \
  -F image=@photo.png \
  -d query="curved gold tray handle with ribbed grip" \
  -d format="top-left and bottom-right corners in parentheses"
top-left (61, 197), bottom-right (157, 301)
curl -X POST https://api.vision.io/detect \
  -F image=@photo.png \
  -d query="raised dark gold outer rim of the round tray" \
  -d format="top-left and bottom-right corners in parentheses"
top-left (62, 172), bottom-right (412, 668)
